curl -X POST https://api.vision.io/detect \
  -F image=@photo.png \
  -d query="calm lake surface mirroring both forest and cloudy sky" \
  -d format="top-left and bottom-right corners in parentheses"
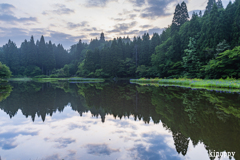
top-left (0, 82), bottom-right (240, 160)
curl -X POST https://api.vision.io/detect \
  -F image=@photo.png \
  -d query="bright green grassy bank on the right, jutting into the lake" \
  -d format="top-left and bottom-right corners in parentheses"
top-left (130, 78), bottom-right (240, 90)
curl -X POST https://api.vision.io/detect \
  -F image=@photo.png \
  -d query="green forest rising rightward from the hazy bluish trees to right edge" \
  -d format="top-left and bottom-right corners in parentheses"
top-left (77, 0), bottom-right (240, 78)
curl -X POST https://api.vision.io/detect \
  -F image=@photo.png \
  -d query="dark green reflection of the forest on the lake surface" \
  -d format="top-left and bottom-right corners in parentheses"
top-left (0, 82), bottom-right (240, 159)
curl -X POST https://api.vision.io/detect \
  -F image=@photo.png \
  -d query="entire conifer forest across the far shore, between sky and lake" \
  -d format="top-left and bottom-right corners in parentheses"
top-left (0, 0), bottom-right (240, 79)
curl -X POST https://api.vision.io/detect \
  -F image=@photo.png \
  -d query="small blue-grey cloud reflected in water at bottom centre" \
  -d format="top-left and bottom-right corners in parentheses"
top-left (85, 144), bottom-right (120, 156)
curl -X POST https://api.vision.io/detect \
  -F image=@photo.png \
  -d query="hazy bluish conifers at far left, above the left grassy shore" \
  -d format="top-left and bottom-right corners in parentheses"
top-left (0, 36), bottom-right (71, 76)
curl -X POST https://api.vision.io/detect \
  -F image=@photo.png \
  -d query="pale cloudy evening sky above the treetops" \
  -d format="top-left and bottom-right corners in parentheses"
top-left (0, 0), bottom-right (229, 49)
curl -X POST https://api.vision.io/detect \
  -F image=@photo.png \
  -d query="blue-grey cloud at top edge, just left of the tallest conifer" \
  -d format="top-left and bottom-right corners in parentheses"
top-left (141, 0), bottom-right (175, 19)
